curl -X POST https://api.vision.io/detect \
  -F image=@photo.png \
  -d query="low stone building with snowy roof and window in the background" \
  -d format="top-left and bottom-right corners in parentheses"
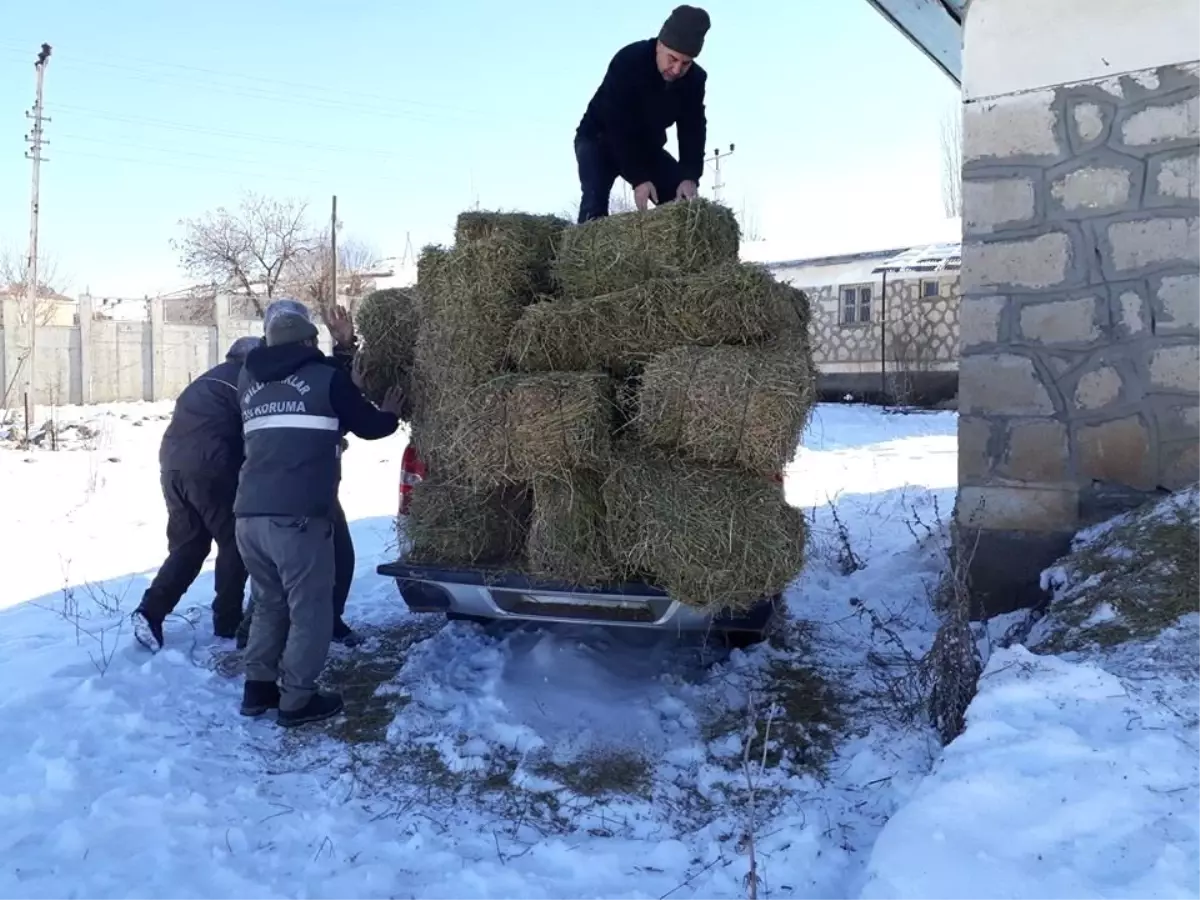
top-left (768, 244), bottom-right (960, 403)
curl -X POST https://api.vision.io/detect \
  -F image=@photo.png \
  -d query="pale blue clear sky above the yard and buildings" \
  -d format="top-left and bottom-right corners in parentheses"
top-left (0, 0), bottom-right (956, 295)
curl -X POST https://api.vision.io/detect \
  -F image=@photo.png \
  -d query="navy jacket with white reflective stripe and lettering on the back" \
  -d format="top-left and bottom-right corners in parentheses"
top-left (234, 344), bottom-right (400, 518)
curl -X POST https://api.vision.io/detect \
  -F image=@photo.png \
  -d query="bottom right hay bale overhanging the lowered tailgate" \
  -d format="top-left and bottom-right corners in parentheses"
top-left (604, 452), bottom-right (805, 611)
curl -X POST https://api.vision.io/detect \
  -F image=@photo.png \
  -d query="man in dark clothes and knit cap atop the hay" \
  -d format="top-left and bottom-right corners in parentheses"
top-left (575, 6), bottom-right (709, 222)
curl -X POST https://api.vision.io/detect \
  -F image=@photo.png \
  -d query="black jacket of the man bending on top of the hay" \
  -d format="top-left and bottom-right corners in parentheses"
top-left (576, 38), bottom-right (708, 186)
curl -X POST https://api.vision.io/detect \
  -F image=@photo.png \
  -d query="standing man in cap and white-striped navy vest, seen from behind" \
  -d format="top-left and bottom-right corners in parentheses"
top-left (234, 312), bottom-right (403, 726)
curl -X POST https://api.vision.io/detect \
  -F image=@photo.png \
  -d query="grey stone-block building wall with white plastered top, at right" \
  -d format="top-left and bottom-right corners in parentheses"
top-left (956, 0), bottom-right (1200, 613)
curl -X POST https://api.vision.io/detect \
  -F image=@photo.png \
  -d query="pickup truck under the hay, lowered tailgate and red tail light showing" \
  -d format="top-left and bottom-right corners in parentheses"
top-left (376, 444), bottom-right (781, 647)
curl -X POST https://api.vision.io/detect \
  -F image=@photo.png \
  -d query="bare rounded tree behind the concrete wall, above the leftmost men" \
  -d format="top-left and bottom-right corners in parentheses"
top-left (172, 193), bottom-right (314, 316)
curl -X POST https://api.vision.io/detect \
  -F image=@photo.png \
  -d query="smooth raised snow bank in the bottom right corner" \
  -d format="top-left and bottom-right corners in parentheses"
top-left (860, 646), bottom-right (1200, 900)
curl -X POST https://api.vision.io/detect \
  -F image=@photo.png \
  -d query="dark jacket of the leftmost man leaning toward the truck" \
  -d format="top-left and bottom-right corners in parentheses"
top-left (158, 344), bottom-right (256, 480)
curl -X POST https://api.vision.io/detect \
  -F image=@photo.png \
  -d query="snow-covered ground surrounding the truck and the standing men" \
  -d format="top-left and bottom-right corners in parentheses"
top-left (0, 404), bottom-right (1200, 900)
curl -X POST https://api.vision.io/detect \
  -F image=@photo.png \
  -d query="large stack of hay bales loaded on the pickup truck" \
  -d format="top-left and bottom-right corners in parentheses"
top-left (393, 200), bottom-right (815, 608)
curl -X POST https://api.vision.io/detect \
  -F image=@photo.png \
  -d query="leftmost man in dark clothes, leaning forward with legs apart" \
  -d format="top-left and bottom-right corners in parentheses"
top-left (133, 337), bottom-right (258, 650)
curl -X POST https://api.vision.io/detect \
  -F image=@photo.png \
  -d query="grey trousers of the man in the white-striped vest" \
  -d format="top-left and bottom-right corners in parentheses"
top-left (236, 516), bottom-right (334, 712)
